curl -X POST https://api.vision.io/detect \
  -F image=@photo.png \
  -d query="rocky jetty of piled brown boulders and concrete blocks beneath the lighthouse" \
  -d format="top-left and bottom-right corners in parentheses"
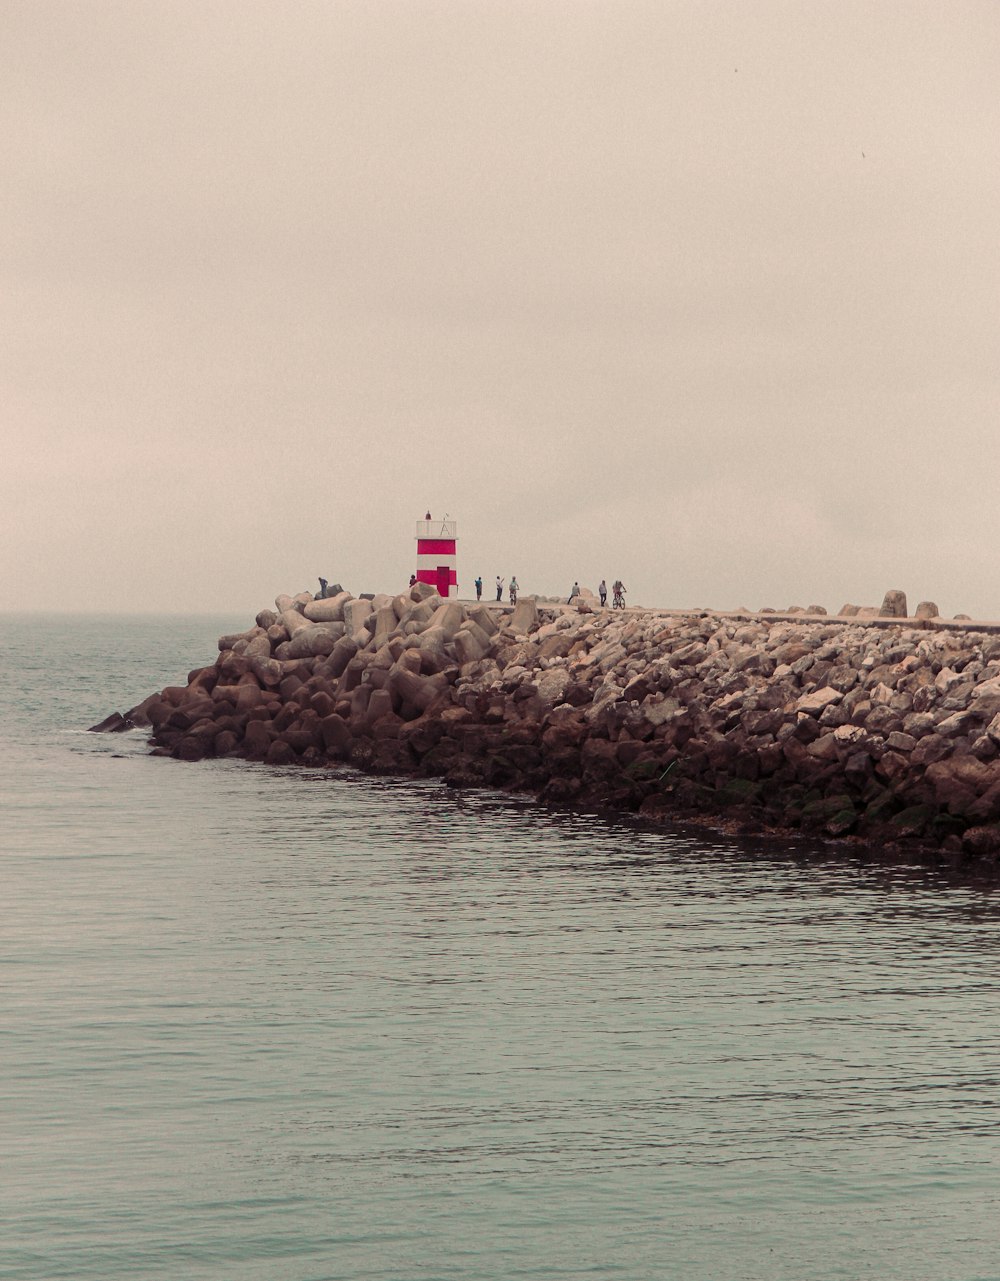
top-left (95, 584), bottom-right (1000, 865)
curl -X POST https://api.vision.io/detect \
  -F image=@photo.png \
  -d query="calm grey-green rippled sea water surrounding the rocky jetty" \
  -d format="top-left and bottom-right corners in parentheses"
top-left (0, 612), bottom-right (1000, 1281)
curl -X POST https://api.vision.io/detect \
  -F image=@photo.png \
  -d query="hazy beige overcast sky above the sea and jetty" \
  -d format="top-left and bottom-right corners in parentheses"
top-left (0, 0), bottom-right (1000, 621)
